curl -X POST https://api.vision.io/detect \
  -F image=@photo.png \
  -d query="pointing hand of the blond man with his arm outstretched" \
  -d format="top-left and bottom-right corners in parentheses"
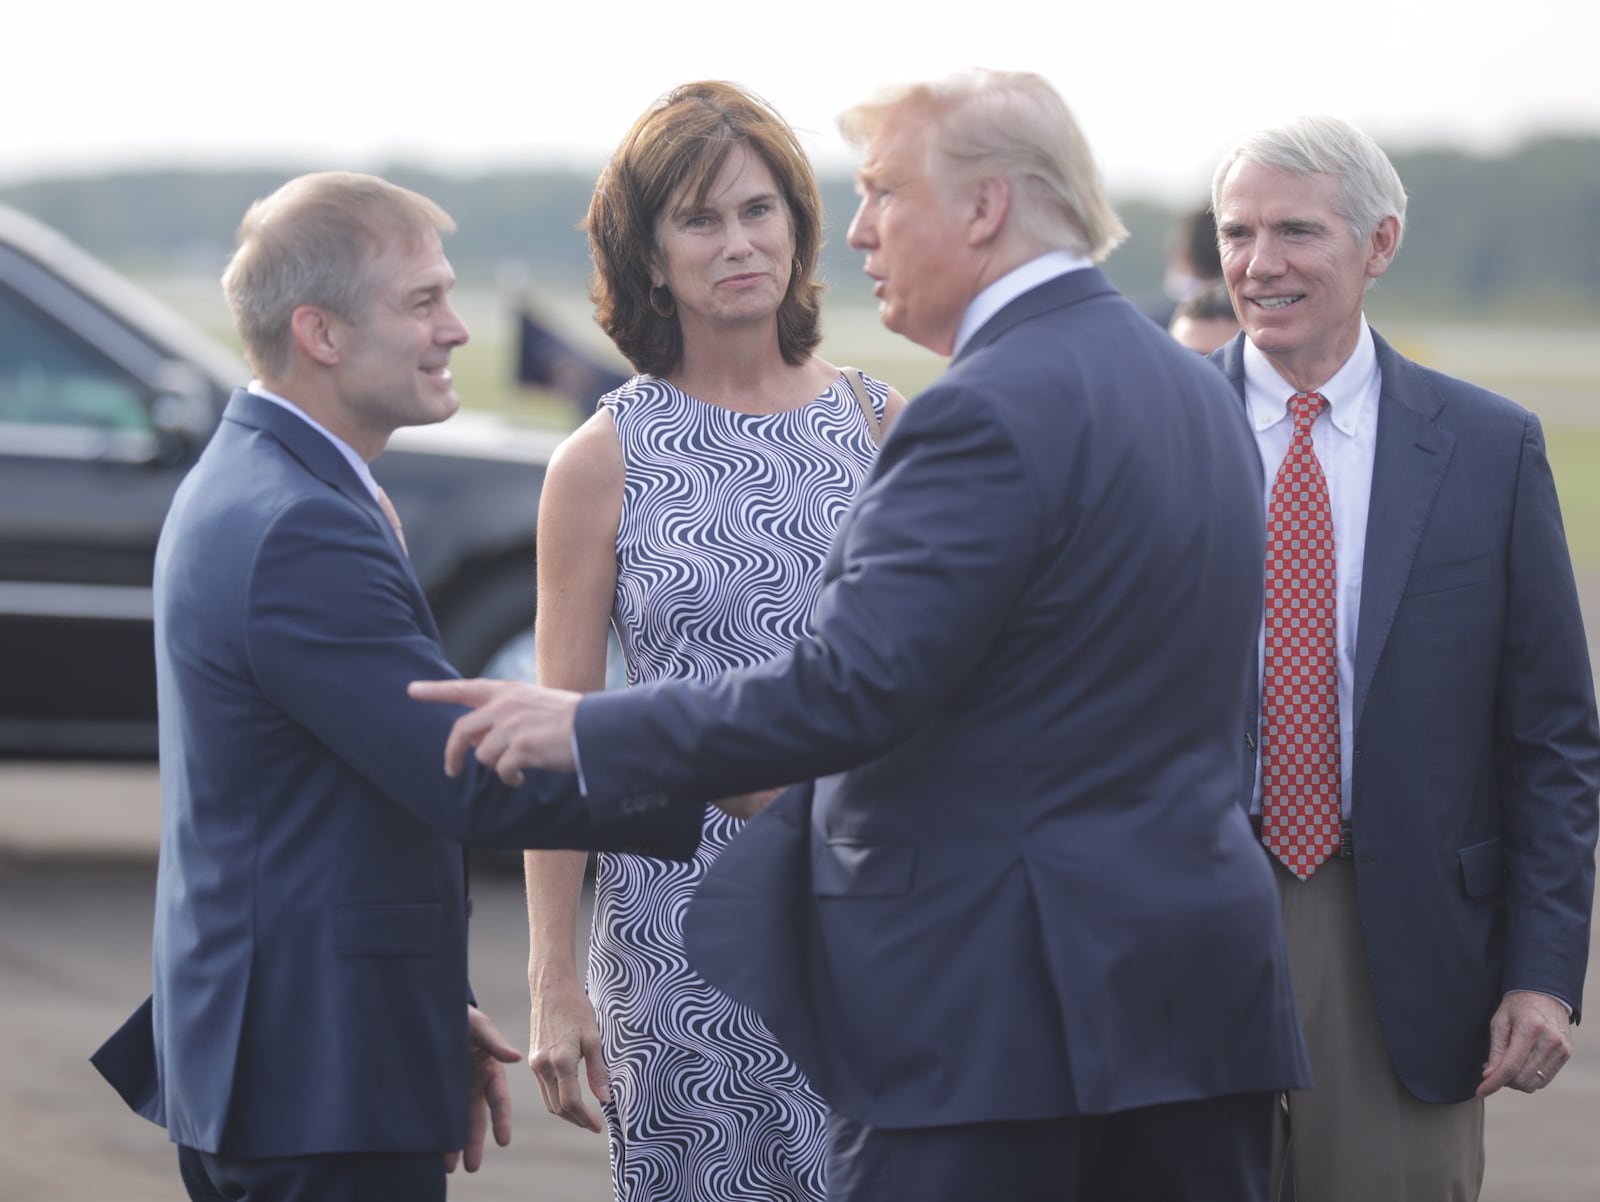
top-left (406, 679), bottom-right (582, 786)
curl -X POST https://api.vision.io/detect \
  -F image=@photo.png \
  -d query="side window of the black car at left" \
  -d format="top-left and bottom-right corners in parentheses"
top-left (0, 286), bottom-right (154, 435)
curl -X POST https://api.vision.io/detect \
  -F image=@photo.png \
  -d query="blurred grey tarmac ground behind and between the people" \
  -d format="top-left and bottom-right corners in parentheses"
top-left (0, 713), bottom-right (1600, 1202)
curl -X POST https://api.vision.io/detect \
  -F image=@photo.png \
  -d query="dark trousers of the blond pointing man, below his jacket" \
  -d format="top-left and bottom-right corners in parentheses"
top-left (827, 1093), bottom-right (1277, 1202)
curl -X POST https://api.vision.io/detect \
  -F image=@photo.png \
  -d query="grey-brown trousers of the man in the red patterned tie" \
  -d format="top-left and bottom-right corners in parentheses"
top-left (1272, 858), bottom-right (1488, 1202)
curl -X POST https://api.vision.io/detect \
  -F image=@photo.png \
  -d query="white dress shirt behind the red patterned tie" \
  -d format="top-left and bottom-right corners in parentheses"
top-left (1245, 317), bottom-right (1382, 818)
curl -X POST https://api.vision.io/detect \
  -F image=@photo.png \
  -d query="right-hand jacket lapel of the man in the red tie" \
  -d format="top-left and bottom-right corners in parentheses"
top-left (1354, 333), bottom-right (1456, 730)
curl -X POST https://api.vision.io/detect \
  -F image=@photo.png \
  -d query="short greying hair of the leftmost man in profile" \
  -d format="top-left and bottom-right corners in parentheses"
top-left (222, 171), bottom-right (456, 379)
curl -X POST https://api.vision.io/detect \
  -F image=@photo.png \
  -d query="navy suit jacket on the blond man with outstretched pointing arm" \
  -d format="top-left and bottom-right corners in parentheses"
top-left (576, 269), bottom-right (1307, 1127)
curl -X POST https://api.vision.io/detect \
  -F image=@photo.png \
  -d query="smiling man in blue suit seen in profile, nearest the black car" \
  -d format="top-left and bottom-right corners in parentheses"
top-left (94, 173), bottom-right (701, 1202)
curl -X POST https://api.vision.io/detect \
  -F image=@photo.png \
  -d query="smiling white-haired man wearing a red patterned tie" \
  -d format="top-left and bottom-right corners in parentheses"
top-left (1213, 117), bottom-right (1600, 1202)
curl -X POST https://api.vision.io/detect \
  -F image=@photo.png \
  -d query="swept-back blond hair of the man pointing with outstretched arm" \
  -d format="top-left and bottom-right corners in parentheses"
top-left (838, 70), bottom-right (1128, 262)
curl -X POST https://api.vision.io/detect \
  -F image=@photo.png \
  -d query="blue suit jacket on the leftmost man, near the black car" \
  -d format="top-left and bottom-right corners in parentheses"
top-left (96, 392), bottom-right (701, 1157)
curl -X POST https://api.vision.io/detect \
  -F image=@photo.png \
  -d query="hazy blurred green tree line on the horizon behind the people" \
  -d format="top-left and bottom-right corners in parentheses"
top-left (0, 134), bottom-right (1600, 325)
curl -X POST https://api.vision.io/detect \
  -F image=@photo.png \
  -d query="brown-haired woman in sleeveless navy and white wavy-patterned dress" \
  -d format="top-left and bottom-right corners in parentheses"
top-left (526, 83), bottom-right (904, 1202)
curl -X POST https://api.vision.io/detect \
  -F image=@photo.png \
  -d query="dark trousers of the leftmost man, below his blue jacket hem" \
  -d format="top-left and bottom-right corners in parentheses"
top-left (178, 1144), bottom-right (445, 1202)
